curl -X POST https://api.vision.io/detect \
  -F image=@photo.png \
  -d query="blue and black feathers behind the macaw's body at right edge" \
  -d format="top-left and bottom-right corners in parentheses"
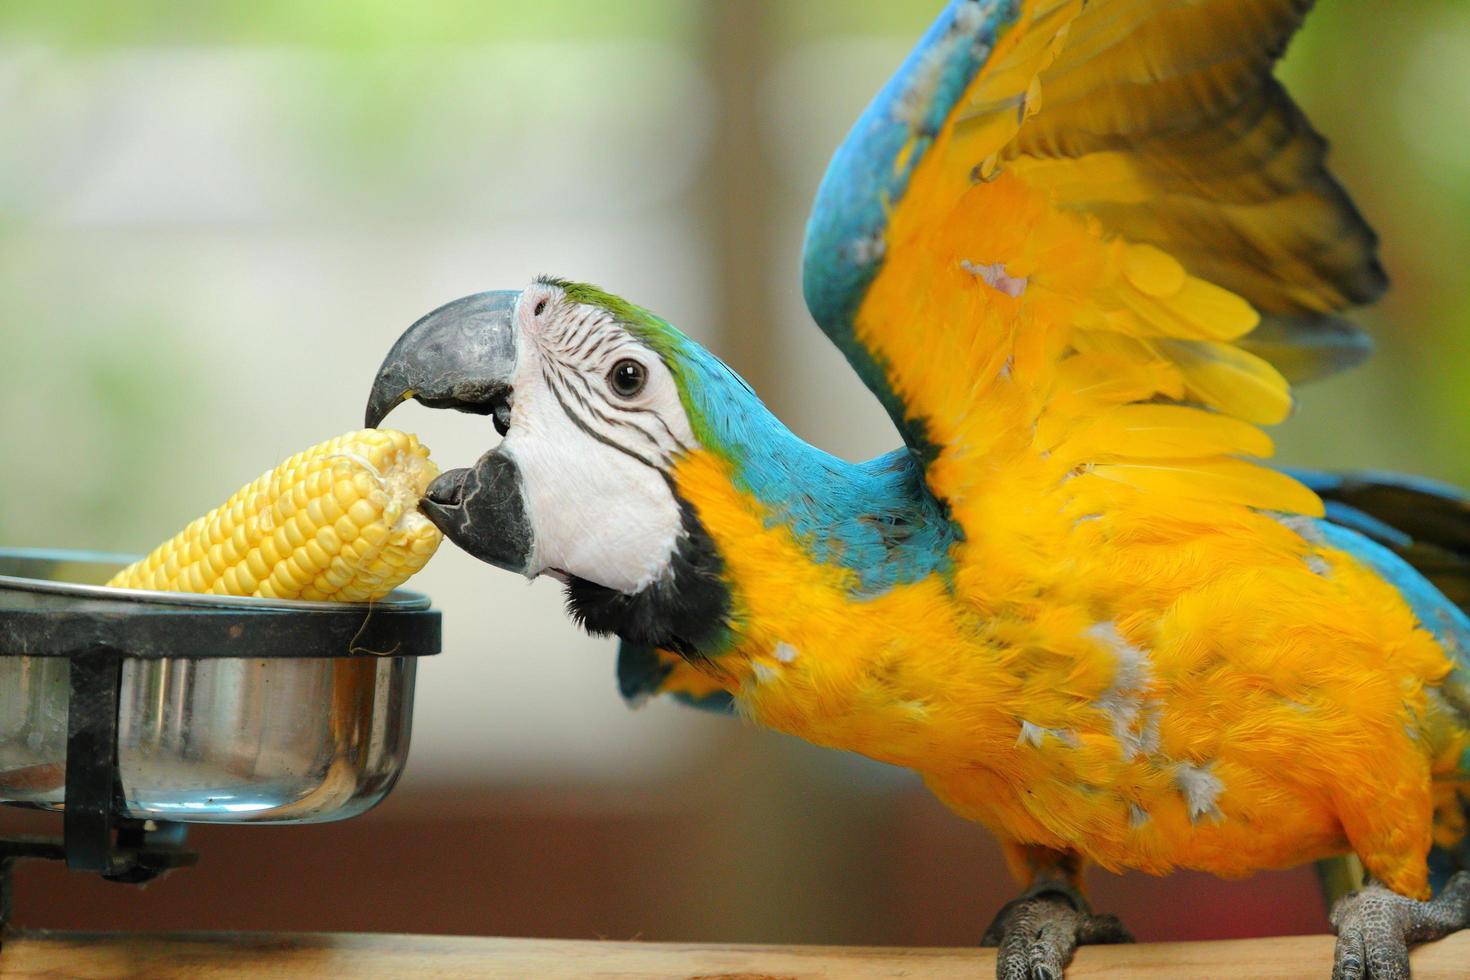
top-left (1292, 472), bottom-right (1470, 890)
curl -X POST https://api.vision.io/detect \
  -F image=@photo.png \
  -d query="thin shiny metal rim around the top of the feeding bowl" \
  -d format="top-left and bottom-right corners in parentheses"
top-left (0, 548), bottom-right (432, 613)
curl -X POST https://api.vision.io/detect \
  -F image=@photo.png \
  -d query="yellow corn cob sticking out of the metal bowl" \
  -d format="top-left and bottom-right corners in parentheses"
top-left (107, 429), bottom-right (442, 602)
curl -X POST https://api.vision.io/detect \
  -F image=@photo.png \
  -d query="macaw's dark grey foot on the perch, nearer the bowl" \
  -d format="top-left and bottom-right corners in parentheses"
top-left (980, 880), bottom-right (1133, 980)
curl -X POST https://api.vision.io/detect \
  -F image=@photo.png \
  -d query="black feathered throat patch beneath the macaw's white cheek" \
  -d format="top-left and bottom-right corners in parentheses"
top-left (566, 482), bottom-right (731, 657)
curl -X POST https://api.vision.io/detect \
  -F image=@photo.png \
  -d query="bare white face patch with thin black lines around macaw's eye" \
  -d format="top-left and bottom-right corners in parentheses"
top-left (503, 284), bottom-right (697, 594)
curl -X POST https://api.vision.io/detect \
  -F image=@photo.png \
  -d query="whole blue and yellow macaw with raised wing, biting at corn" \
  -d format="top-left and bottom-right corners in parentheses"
top-left (368, 0), bottom-right (1470, 977)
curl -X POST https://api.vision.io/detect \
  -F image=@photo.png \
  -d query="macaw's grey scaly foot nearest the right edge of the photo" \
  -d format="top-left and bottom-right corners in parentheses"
top-left (1332, 871), bottom-right (1470, 980)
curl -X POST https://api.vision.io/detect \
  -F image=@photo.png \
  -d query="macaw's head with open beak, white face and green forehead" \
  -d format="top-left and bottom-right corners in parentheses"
top-left (366, 279), bottom-right (746, 651)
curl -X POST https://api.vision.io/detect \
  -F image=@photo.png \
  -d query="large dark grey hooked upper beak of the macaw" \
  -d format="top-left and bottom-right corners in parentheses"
top-left (366, 289), bottom-right (520, 435)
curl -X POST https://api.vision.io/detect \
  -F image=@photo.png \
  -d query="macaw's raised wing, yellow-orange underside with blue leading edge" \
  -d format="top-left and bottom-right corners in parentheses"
top-left (804, 0), bottom-right (1385, 529)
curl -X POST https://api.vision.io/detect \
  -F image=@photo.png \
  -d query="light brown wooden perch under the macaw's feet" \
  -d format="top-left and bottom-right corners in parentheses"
top-left (0, 932), bottom-right (1470, 980)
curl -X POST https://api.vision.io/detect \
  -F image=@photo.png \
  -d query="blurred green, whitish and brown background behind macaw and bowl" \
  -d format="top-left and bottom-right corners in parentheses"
top-left (0, 0), bottom-right (1470, 943)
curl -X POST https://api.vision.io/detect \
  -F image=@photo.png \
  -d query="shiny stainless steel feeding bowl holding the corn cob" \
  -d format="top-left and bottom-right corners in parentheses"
top-left (0, 551), bottom-right (438, 823)
